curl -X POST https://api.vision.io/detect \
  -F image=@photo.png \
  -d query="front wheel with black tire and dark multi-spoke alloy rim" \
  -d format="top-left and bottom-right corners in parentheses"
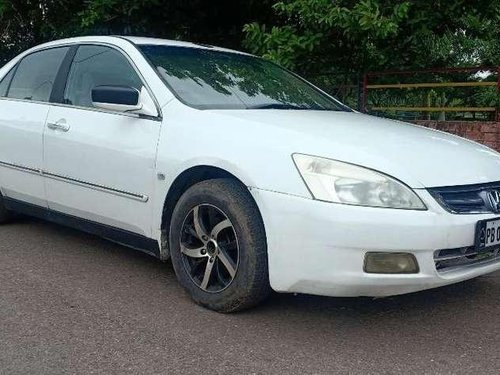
top-left (169, 178), bottom-right (271, 313)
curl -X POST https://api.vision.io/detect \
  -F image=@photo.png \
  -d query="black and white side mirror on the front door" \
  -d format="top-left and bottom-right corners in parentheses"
top-left (92, 86), bottom-right (142, 112)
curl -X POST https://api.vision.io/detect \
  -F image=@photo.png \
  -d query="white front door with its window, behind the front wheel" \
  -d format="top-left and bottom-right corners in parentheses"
top-left (44, 44), bottom-right (161, 237)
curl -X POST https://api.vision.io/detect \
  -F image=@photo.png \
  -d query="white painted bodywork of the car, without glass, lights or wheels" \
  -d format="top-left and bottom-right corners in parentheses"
top-left (0, 37), bottom-right (500, 296)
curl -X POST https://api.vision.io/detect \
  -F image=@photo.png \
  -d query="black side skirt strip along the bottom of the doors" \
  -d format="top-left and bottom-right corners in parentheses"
top-left (3, 197), bottom-right (160, 258)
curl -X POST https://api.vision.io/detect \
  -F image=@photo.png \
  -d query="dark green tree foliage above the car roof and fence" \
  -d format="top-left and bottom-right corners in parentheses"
top-left (0, 0), bottom-right (500, 73)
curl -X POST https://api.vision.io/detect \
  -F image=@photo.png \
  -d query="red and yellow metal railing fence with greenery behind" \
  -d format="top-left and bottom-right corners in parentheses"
top-left (312, 67), bottom-right (500, 121)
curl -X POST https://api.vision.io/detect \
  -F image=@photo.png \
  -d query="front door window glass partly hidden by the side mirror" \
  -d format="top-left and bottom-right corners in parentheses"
top-left (64, 46), bottom-right (142, 107)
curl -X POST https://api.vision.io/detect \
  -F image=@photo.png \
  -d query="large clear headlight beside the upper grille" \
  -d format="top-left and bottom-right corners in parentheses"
top-left (293, 154), bottom-right (427, 210)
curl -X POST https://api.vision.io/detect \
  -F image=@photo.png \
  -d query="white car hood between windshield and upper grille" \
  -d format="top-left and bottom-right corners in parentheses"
top-left (211, 110), bottom-right (500, 188)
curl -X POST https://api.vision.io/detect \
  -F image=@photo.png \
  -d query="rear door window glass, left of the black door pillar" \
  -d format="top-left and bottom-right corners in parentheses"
top-left (7, 47), bottom-right (69, 102)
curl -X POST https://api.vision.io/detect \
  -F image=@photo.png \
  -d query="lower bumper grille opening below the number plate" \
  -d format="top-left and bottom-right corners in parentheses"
top-left (434, 247), bottom-right (500, 272)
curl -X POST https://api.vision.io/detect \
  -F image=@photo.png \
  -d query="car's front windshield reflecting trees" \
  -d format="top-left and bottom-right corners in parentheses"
top-left (139, 45), bottom-right (349, 111)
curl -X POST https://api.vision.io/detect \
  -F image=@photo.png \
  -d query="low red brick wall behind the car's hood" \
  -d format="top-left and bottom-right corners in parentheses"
top-left (412, 120), bottom-right (500, 151)
